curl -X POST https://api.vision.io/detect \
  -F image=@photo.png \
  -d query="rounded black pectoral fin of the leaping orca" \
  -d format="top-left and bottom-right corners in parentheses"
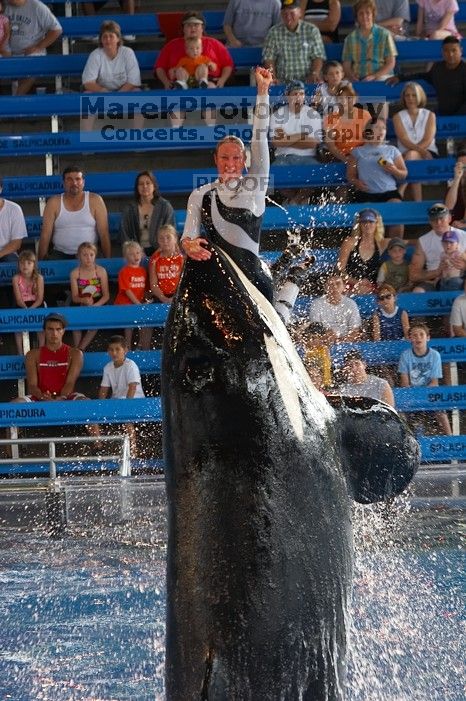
top-left (327, 395), bottom-right (420, 504)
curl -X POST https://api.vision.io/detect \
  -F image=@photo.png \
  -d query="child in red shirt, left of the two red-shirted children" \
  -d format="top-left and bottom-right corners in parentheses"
top-left (115, 241), bottom-right (147, 348)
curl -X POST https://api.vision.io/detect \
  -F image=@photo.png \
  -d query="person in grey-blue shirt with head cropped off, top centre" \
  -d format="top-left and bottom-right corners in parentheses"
top-left (223, 0), bottom-right (280, 48)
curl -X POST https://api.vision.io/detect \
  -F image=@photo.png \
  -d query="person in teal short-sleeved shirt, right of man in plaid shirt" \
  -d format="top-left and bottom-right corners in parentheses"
top-left (342, 0), bottom-right (398, 81)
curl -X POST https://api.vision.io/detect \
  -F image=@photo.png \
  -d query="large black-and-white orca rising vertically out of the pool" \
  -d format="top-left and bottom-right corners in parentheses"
top-left (162, 245), bottom-right (419, 701)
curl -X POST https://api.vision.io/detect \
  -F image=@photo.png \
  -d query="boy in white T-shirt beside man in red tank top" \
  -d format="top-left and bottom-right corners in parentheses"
top-left (89, 336), bottom-right (145, 456)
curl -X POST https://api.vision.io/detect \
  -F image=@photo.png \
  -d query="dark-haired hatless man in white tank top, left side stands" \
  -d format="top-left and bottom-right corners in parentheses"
top-left (39, 166), bottom-right (111, 259)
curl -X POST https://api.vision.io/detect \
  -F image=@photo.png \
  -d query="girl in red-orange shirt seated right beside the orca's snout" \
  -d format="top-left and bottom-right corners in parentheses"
top-left (149, 224), bottom-right (184, 304)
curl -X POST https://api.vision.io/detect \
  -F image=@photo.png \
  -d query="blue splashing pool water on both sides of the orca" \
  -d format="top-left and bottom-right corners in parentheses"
top-left (0, 482), bottom-right (466, 701)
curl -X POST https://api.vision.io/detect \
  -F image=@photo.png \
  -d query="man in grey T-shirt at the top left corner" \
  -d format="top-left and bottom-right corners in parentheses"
top-left (5, 0), bottom-right (63, 95)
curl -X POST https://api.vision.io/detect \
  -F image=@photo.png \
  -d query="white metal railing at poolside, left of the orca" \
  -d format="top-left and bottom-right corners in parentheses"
top-left (0, 434), bottom-right (131, 480)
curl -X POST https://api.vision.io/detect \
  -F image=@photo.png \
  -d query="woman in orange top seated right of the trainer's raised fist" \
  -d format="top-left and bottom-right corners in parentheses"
top-left (324, 84), bottom-right (371, 162)
